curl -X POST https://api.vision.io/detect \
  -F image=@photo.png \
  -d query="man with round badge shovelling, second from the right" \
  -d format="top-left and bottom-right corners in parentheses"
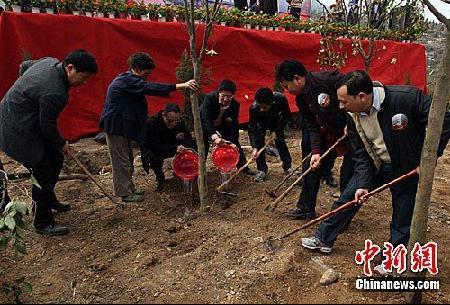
top-left (276, 60), bottom-right (353, 219)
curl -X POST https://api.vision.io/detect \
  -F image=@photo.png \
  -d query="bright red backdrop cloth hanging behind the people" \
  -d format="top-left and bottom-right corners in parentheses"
top-left (0, 12), bottom-right (426, 140)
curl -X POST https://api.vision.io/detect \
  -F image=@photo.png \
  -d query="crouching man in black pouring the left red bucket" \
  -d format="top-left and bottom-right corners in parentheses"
top-left (141, 103), bottom-right (197, 191)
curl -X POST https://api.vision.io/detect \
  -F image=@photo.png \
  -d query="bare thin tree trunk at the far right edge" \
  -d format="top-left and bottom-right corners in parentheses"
top-left (405, 24), bottom-right (450, 304)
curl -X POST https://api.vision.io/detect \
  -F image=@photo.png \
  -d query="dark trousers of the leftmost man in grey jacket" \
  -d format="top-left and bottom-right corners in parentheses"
top-left (31, 144), bottom-right (64, 228)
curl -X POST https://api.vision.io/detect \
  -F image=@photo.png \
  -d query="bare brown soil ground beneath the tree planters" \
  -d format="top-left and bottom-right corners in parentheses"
top-left (0, 132), bottom-right (450, 304)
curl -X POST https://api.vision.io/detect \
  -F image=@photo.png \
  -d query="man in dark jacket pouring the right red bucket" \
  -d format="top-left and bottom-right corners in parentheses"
top-left (200, 79), bottom-right (254, 175)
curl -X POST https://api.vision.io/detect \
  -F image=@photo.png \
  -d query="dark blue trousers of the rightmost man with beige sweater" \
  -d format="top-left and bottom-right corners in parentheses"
top-left (315, 164), bottom-right (419, 247)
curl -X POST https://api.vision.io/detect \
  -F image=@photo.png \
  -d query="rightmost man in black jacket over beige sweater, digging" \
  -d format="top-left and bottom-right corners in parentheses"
top-left (302, 71), bottom-right (450, 268)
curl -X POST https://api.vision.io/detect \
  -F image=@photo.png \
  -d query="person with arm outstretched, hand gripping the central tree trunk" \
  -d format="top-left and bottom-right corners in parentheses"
top-left (100, 52), bottom-right (199, 202)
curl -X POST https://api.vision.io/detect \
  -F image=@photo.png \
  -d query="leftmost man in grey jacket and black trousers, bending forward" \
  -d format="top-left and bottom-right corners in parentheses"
top-left (0, 50), bottom-right (98, 235)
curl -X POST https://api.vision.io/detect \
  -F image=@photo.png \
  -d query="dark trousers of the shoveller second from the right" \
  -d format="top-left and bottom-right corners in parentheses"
top-left (297, 130), bottom-right (354, 213)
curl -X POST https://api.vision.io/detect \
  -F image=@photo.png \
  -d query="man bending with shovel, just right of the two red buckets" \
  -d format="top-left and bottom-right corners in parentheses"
top-left (248, 88), bottom-right (292, 182)
